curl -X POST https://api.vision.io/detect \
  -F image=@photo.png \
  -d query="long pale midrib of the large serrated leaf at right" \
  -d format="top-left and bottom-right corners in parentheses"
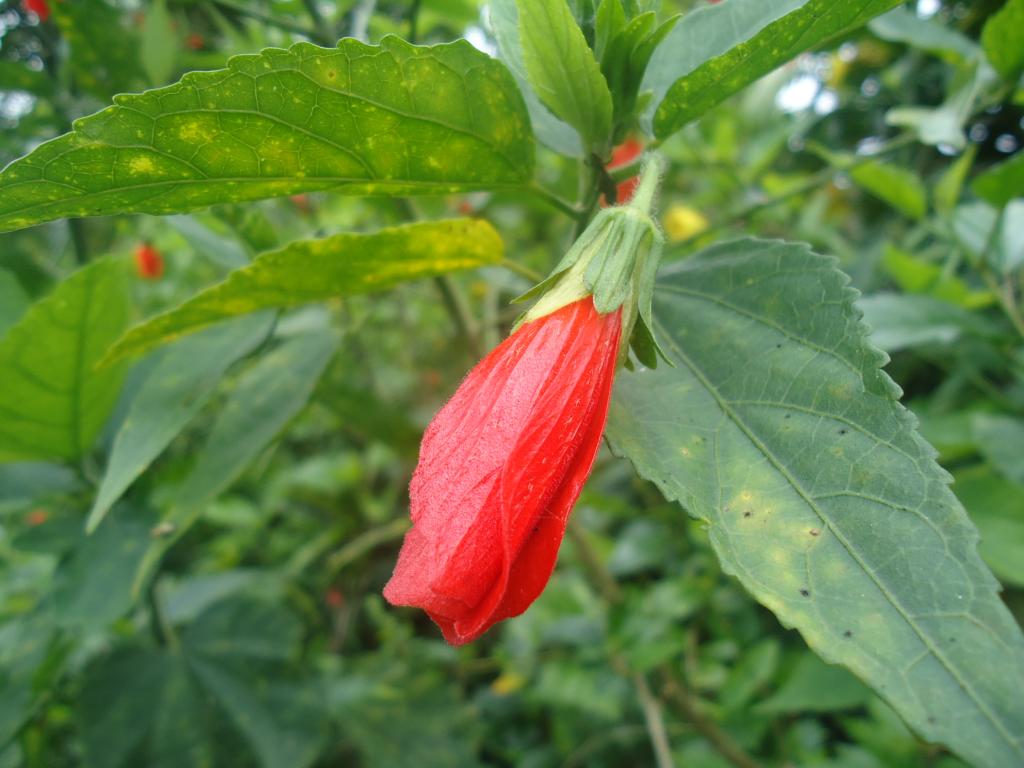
top-left (654, 319), bottom-right (1024, 755)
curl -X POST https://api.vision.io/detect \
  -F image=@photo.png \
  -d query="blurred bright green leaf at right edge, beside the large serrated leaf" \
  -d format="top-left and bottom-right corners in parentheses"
top-left (953, 462), bottom-right (1024, 587)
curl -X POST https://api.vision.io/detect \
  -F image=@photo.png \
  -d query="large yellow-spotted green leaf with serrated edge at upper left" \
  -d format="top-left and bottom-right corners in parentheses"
top-left (0, 37), bottom-right (534, 230)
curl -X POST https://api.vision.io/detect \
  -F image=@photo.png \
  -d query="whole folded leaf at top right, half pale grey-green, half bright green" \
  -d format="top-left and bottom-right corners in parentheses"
top-left (643, 0), bottom-right (899, 138)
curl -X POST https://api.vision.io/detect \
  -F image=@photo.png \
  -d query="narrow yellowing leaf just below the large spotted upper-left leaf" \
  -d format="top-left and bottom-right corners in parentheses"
top-left (104, 218), bottom-right (504, 362)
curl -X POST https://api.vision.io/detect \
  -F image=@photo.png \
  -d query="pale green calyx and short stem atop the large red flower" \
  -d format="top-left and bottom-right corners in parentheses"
top-left (516, 156), bottom-right (668, 368)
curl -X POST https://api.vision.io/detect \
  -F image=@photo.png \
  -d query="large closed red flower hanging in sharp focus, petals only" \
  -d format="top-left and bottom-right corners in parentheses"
top-left (384, 296), bottom-right (623, 645)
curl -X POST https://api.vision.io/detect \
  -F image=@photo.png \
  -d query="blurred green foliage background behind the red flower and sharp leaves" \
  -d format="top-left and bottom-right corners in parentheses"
top-left (0, 0), bottom-right (1024, 768)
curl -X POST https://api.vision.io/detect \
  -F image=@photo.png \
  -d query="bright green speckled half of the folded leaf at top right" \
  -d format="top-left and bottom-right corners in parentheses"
top-left (654, 0), bottom-right (900, 138)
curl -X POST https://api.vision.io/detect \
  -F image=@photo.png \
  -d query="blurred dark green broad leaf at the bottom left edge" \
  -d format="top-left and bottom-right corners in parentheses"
top-left (78, 598), bottom-right (327, 768)
